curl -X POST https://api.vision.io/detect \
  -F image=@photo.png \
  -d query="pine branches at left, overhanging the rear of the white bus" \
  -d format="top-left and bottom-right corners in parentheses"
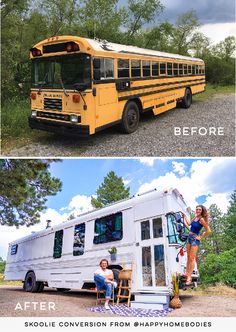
top-left (0, 159), bottom-right (62, 227)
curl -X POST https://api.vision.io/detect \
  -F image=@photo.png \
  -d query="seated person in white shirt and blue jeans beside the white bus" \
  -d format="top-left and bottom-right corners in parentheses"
top-left (94, 259), bottom-right (117, 310)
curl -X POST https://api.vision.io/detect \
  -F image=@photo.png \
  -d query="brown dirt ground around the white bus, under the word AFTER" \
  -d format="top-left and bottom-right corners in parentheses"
top-left (0, 286), bottom-right (236, 317)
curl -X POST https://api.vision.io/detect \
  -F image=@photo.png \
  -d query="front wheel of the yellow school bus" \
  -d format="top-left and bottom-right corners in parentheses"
top-left (121, 101), bottom-right (139, 134)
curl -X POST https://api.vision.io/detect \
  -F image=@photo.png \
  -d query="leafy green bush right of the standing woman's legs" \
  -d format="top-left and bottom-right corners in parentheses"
top-left (199, 248), bottom-right (236, 288)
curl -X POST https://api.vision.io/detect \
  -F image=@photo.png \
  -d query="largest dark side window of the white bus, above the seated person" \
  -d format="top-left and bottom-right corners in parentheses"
top-left (93, 212), bottom-right (123, 244)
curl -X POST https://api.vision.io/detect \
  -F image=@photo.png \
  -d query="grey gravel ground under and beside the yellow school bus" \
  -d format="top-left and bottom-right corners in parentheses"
top-left (3, 94), bottom-right (235, 157)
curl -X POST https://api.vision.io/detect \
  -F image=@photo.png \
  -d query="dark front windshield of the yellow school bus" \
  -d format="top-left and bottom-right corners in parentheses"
top-left (31, 54), bottom-right (91, 89)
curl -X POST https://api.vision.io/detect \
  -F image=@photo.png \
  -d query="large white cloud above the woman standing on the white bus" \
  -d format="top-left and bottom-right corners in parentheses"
top-left (138, 158), bottom-right (236, 212)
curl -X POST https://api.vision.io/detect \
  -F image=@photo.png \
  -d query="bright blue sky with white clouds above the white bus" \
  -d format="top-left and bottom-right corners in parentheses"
top-left (0, 157), bottom-right (236, 259)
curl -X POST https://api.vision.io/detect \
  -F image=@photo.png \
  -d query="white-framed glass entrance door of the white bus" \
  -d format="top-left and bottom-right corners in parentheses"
top-left (136, 216), bottom-right (167, 290)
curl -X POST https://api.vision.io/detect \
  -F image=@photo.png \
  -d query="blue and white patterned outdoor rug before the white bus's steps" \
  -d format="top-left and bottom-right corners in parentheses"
top-left (90, 304), bottom-right (174, 317)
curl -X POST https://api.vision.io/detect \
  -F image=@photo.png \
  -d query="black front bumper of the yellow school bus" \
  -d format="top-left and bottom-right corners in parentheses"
top-left (29, 117), bottom-right (90, 137)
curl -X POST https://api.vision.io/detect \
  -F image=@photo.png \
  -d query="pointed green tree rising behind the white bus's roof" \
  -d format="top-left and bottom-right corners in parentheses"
top-left (91, 171), bottom-right (130, 208)
